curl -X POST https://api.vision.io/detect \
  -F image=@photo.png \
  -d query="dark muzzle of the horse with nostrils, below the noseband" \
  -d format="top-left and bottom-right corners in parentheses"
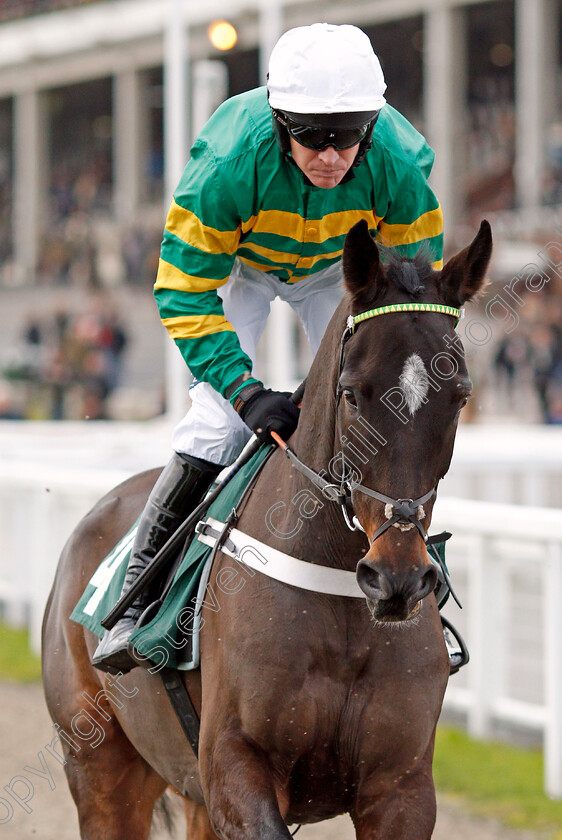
top-left (356, 557), bottom-right (437, 623)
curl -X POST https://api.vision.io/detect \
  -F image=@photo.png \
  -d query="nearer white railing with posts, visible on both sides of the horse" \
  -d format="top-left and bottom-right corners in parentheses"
top-left (0, 452), bottom-right (562, 797)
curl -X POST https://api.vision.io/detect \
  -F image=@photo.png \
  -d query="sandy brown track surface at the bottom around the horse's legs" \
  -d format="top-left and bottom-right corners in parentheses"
top-left (0, 683), bottom-right (538, 840)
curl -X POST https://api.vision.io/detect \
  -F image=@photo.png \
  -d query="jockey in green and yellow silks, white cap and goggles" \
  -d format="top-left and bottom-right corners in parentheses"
top-left (93, 23), bottom-right (443, 672)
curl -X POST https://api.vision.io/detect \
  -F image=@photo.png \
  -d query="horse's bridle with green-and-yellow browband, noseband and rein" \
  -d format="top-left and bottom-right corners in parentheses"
top-left (271, 303), bottom-right (462, 545)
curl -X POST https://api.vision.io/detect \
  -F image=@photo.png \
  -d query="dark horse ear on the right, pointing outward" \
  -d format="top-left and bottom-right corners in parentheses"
top-left (439, 219), bottom-right (492, 304)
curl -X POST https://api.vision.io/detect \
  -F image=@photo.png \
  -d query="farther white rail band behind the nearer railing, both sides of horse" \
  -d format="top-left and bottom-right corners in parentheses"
top-left (0, 418), bottom-right (562, 507)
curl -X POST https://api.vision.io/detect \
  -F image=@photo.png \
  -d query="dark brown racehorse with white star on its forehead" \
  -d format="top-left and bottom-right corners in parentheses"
top-left (43, 221), bottom-right (492, 840)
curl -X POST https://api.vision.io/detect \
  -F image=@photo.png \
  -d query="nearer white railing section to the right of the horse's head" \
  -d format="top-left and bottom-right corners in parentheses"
top-left (431, 498), bottom-right (562, 798)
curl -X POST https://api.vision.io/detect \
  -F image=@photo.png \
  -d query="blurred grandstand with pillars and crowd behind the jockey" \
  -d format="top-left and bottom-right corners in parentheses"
top-left (0, 0), bottom-right (562, 422)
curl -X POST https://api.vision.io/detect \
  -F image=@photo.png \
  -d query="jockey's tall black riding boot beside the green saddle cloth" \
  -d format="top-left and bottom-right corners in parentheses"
top-left (92, 453), bottom-right (223, 674)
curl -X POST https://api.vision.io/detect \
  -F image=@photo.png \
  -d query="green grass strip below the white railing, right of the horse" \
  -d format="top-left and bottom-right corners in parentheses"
top-left (433, 726), bottom-right (562, 840)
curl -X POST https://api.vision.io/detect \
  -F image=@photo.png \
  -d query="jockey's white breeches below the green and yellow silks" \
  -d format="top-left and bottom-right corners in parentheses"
top-left (172, 259), bottom-right (343, 466)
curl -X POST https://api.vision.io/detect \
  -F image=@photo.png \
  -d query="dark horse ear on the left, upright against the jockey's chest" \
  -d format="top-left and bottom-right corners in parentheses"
top-left (342, 219), bottom-right (383, 306)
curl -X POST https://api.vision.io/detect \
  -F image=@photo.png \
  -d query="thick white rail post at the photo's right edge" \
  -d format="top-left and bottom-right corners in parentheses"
top-left (544, 541), bottom-right (562, 799)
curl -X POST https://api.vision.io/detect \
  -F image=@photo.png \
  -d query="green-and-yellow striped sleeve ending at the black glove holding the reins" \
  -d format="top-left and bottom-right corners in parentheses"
top-left (154, 153), bottom-right (258, 396)
